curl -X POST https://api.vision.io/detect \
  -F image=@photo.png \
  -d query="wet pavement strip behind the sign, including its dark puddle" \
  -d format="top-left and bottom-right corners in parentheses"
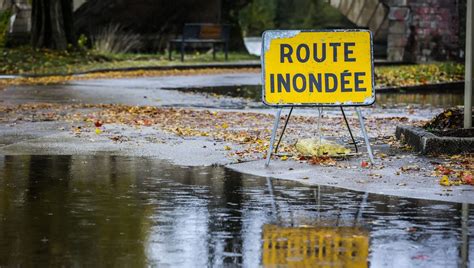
top-left (0, 73), bottom-right (463, 113)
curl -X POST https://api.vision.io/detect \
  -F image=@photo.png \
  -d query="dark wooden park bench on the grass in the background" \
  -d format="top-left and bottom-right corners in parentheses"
top-left (168, 23), bottom-right (230, 61)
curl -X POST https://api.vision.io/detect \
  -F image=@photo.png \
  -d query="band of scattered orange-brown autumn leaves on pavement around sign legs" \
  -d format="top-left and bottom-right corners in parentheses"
top-left (0, 103), bottom-right (474, 185)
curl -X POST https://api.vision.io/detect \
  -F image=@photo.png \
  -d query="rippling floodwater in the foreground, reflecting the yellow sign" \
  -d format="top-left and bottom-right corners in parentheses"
top-left (0, 155), bottom-right (474, 267)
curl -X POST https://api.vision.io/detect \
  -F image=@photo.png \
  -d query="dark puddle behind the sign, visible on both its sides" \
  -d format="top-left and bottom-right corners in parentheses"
top-left (167, 86), bottom-right (464, 108)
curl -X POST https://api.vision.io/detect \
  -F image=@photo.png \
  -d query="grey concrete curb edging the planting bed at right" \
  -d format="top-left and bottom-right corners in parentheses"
top-left (395, 126), bottom-right (474, 154)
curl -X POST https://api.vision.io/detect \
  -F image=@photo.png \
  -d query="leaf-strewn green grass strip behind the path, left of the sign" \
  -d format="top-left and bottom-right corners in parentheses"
top-left (0, 47), bottom-right (258, 75)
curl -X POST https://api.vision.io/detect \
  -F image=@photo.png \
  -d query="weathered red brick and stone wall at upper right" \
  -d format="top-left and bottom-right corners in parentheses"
top-left (384, 0), bottom-right (459, 61)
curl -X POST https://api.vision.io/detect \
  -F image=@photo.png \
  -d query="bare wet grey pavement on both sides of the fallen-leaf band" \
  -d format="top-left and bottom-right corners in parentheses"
top-left (0, 73), bottom-right (474, 203)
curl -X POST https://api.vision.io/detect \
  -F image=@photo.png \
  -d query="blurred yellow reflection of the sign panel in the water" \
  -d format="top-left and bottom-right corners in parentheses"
top-left (262, 225), bottom-right (369, 267)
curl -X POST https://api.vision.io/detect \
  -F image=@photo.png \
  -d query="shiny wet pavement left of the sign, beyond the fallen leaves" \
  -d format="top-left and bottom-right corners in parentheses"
top-left (0, 73), bottom-right (260, 108)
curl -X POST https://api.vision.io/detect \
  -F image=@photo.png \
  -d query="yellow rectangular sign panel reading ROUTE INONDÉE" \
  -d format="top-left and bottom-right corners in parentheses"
top-left (262, 30), bottom-right (375, 106)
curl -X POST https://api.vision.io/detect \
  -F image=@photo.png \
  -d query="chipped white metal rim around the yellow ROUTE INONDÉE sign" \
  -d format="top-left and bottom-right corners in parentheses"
top-left (260, 29), bottom-right (376, 107)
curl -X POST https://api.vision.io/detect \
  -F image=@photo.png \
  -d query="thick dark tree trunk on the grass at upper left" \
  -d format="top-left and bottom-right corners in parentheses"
top-left (31, 0), bottom-right (75, 50)
